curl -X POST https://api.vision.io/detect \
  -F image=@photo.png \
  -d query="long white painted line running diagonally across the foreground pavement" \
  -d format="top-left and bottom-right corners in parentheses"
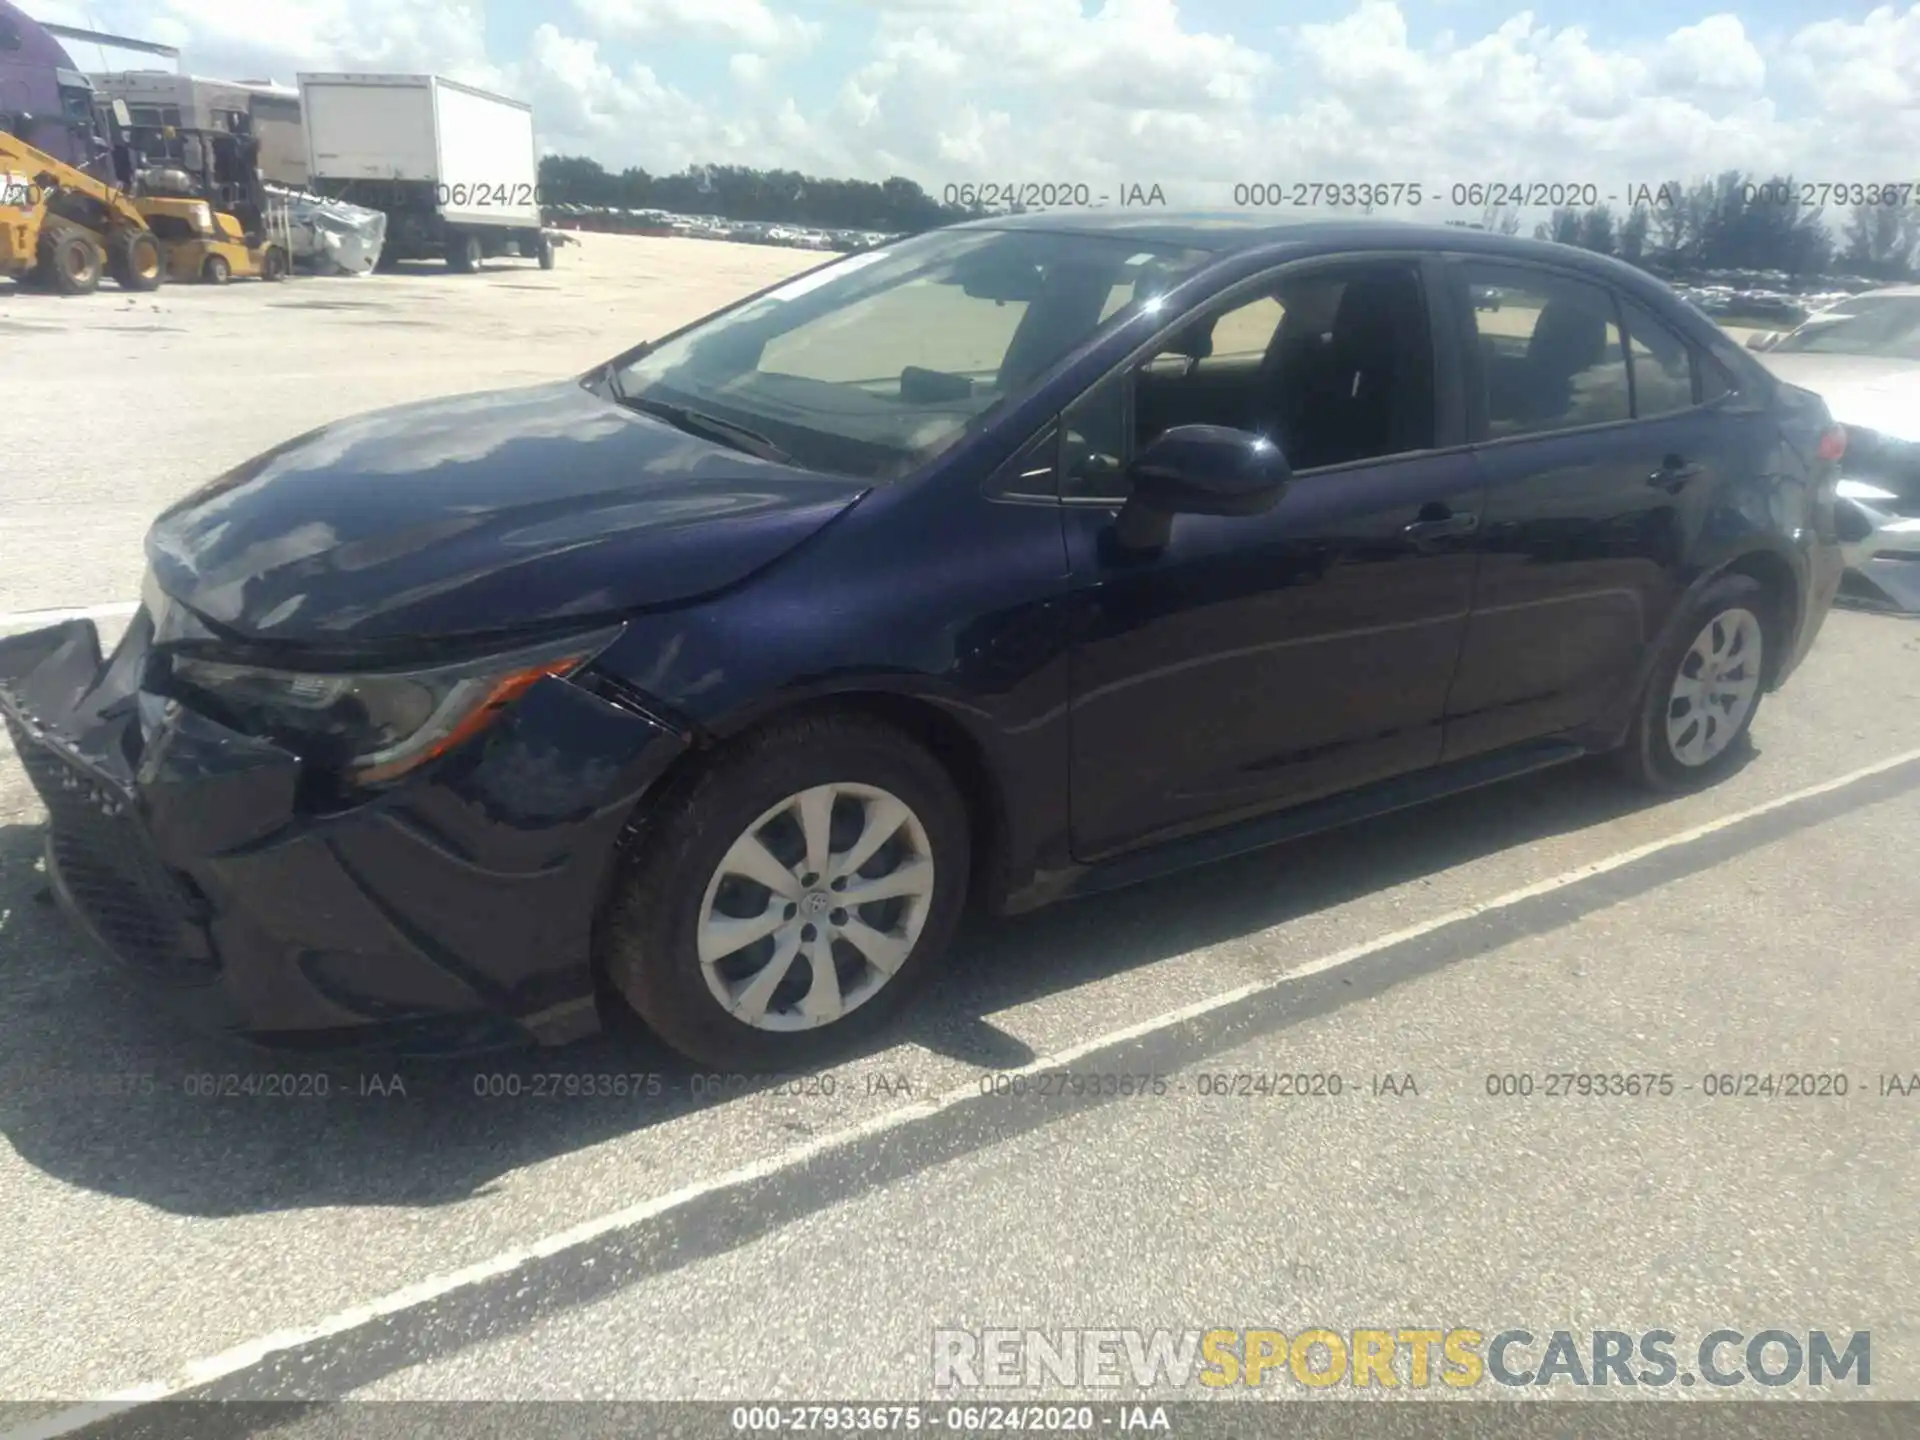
top-left (11, 749), bottom-right (1920, 1440)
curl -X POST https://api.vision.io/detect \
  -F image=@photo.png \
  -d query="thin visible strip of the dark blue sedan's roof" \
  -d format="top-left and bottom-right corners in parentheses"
top-left (936, 209), bottom-right (1638, 276)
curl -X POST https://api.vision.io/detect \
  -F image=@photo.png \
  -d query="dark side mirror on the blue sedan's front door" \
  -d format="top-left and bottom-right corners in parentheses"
top-left (1117, 424), bottom-right (1292, 549)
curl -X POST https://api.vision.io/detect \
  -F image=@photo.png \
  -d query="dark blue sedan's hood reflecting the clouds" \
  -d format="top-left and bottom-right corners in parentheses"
top-left (146, 380), bottom-right (868, 649)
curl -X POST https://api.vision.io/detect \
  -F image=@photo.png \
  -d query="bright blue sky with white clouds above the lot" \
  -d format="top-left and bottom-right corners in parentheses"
top-left (25, 0), bottom-right (1920, 204)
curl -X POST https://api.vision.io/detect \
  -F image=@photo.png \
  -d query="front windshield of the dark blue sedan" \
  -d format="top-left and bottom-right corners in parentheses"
top-left (616, 228), bottom-right (1210, 480)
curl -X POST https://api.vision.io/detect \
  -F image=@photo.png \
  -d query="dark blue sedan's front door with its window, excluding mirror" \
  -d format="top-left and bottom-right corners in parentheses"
top-left (1062, 261), bottom-right (1480, 860)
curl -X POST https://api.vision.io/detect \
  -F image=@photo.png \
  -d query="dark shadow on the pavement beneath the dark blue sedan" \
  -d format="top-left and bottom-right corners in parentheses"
top-left (0, 762), bottom-right (1735, 1215)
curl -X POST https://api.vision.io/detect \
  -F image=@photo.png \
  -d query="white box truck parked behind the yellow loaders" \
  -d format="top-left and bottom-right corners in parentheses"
top-left (300, 73), bottom-right (553, 273)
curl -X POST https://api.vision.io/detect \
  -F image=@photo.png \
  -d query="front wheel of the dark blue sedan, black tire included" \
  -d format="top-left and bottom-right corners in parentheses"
top-left (599, 714), bottom-right (972, 1071)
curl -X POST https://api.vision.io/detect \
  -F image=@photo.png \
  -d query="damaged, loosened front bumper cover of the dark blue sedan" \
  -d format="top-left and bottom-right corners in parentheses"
top-left (0, 612), bottom-right (685, 1048)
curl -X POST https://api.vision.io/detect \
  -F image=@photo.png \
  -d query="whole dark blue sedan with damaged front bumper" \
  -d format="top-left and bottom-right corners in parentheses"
top-left (0, 215), bottom-right (1843, 1069)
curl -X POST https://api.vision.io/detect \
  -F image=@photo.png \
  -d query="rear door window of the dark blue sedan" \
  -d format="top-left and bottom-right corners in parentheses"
top-left (1463, 265), bottom-right (1632, 440)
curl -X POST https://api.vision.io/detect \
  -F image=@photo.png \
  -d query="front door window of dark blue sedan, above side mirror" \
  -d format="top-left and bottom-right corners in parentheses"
top-left (1060, 263), bottom-right (1434, 501)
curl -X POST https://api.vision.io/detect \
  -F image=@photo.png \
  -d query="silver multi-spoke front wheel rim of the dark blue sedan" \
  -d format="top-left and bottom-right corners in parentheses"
top-left (697, 783), bottom-right (933, 1031)
